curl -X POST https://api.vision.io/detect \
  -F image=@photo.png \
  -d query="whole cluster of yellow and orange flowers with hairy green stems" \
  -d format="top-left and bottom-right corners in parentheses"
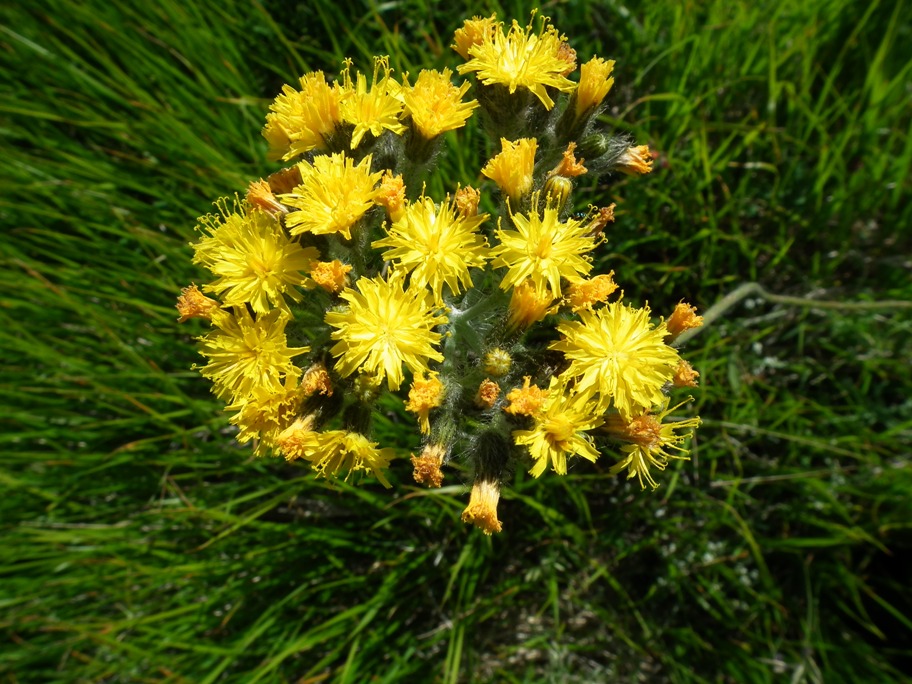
top-left (177, 16), bottom-right (701, 534)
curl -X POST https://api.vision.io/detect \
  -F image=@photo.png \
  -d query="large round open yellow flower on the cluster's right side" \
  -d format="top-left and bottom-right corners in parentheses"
top-left (549, 302), bottom-right (679, 418)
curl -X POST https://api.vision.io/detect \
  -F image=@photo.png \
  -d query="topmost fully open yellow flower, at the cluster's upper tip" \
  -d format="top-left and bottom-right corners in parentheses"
top-left (458, 18), bottom-right (575, 109)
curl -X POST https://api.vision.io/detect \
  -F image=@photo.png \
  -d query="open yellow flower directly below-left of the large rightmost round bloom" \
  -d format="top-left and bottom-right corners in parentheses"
top-left (513, 377), bottom-right (604, 477)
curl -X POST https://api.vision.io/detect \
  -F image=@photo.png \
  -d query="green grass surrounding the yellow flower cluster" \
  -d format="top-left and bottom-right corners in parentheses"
top-left (0, 0), bottom-right (912, 682)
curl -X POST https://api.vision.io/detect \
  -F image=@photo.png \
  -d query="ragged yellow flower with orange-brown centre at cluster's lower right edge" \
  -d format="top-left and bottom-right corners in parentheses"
top-left (607, 397), bottom-right (700, 489)
